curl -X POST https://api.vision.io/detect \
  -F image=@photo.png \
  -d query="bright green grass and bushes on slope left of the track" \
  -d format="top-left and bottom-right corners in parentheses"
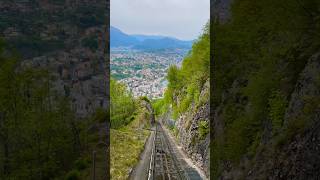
top-left (110, 79), bottom-right (151, 179)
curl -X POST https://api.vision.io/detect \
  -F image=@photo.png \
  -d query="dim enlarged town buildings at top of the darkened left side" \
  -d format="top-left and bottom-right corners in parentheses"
top-left (0, 0), bottom-right (108, 117)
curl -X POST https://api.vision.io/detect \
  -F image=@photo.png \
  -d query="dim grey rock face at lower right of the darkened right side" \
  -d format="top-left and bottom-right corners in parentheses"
top-left (219, 53), bottom-right (320, 180)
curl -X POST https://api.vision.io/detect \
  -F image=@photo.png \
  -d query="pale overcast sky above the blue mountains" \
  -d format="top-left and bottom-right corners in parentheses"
top-left (110, 0), bottom-right (210, 40)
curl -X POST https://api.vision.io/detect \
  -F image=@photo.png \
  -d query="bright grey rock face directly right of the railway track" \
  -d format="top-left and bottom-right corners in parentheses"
top-left (165, 81), bottom-right (210, 177)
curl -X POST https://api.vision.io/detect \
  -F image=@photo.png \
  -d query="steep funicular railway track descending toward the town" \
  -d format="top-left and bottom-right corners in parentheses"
top-left (148, 123), bottom-right (202, 180)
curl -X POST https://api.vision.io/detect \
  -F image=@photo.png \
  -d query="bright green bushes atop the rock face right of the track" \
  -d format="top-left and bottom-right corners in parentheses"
top-left (154, 24), bottom-right (210, 119)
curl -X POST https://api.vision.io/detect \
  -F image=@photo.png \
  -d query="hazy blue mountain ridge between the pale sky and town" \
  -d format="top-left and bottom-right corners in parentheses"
top-left (110, 26), bottom-right (193, 50)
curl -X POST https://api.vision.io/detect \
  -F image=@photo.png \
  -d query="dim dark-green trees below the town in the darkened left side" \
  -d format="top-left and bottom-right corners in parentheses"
top-left (0, 41), bottom-right (106, 179)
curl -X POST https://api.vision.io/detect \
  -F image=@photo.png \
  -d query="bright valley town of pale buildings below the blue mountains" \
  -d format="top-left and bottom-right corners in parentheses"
top-left (111, 51), bottom-right (184, 99)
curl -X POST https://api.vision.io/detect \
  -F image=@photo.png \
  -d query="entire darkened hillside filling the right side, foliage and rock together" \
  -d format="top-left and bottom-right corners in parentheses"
top-left (211, 0), bottom-right (320, 179)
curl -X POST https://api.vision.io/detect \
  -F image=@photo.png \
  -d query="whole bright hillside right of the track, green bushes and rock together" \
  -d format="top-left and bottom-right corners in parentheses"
top-left (153, 22), bottom-right (210, 176)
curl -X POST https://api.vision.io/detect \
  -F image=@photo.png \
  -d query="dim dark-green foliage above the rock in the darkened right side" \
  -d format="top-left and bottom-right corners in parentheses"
top-left (211, 0), bottom-right (320, 177)
